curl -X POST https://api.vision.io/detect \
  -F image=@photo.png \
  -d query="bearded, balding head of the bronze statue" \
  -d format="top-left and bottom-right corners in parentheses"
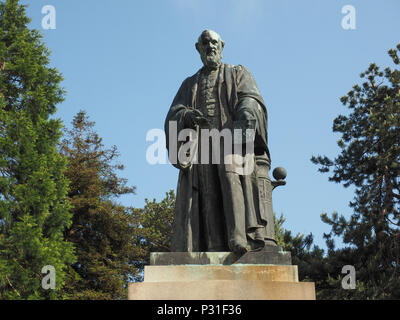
top-left (196, 30), bottom-right (225, 69)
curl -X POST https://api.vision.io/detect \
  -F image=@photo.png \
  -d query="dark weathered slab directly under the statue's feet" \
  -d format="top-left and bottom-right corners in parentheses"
top-left (150, 247), bottom-right (292, 265)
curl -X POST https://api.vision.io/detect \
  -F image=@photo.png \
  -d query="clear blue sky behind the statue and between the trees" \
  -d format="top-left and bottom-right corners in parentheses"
top-left (22, 0), bottom-right (400, 247)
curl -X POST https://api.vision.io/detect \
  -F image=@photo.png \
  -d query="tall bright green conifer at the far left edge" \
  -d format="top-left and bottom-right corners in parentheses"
top-left (0, 0), bottom-right (74, 299)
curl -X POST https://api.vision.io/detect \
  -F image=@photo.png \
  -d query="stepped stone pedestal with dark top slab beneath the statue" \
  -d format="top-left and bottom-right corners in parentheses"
top-left (128, 247), bottom-right (315, 300)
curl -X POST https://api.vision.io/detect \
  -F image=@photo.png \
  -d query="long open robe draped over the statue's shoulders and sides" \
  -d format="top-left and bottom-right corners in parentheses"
top-left (165, 64), bottom-right (274, 252)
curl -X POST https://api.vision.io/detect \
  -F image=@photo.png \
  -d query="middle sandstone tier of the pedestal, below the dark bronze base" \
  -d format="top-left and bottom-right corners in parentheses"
top-left (144, 264), bottom-right (299, 282)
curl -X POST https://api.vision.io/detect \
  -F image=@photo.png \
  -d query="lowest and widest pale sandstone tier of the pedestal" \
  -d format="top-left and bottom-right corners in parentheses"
top-left (128, 280), bottom-right (315, 300)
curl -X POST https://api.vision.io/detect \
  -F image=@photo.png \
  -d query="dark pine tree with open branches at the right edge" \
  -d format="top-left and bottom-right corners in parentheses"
top-left (312, 44), bottom-right (400, 299)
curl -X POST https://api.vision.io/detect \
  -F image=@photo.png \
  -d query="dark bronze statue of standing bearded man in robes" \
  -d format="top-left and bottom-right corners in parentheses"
top-left (165, 30), bottom-right (276, 254)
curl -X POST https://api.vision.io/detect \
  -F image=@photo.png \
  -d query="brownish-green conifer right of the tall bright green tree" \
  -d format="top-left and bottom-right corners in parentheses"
top-left (61, 111), bottom-right (139, 300)
